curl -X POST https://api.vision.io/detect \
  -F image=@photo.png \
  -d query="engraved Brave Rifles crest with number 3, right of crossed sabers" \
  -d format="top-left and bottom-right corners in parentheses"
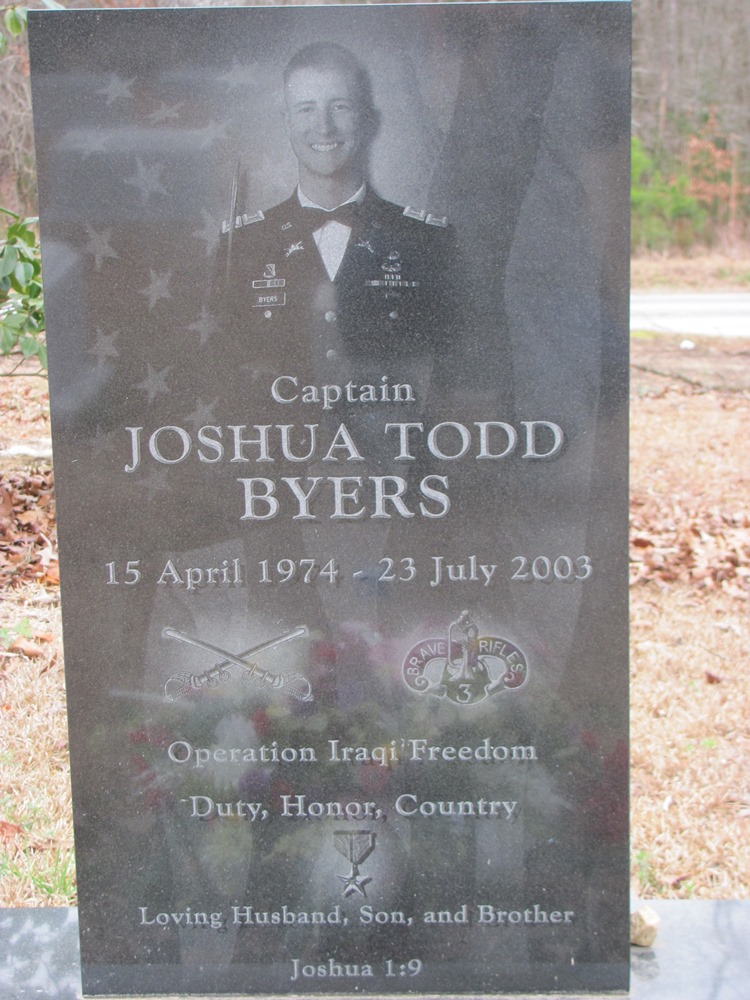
top-left (402, 611), bottom-right (529, 705)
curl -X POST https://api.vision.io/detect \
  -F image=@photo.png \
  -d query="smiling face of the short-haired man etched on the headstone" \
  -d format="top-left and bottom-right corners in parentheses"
top-left (285, 66), bottom-right (365, 187)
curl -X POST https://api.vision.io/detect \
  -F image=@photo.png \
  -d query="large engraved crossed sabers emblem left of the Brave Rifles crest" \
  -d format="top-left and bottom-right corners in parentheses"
top-left (162, 625), bottom-right (313, 701)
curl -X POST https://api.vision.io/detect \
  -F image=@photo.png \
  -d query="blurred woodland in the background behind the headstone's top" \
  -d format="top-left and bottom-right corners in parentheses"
top-left (0, 0), bottom-right (750, 253)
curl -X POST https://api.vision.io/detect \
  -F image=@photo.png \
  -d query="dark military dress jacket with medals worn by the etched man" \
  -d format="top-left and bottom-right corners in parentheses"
top-left (222, 189), bottom-right (455, 382)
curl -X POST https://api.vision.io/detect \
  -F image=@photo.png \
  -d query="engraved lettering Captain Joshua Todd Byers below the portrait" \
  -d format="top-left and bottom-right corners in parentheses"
top-left (123, 375), bottom-right (565, 521)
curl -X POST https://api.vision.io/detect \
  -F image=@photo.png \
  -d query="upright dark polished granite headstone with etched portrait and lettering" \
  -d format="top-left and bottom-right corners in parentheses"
top-left (29, 0), bottom-right (630, 995)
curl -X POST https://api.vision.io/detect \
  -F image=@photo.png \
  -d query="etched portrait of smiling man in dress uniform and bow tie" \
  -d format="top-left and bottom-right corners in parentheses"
top-left (214, 42), bottom-right (455, 378)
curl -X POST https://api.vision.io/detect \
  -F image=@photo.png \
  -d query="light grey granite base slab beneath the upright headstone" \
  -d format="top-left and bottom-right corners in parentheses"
top-left (0, 900), bottom-right (750, 1000)
